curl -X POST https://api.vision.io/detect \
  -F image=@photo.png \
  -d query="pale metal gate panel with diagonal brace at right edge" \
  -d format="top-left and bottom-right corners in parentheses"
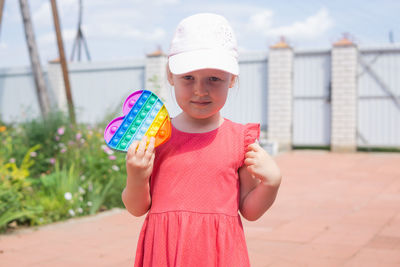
top-left (357, 46), bottom-right (400, 147)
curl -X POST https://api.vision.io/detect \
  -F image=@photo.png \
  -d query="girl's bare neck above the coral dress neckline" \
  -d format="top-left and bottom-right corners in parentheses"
top-left (172, 112), bottom-right (224, 133)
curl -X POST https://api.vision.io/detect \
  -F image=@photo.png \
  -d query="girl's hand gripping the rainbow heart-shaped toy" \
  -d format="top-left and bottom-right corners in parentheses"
top-left (126, 136), bottom-right (155, 183)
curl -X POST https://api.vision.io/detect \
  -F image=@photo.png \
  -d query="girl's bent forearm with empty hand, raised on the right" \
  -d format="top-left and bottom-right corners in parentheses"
top-left (239, 143), bottom-right (282, 221)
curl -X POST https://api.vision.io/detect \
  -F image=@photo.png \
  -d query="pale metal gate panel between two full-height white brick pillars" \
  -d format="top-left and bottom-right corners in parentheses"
top-left (292, 50), bottom-right (331, 147)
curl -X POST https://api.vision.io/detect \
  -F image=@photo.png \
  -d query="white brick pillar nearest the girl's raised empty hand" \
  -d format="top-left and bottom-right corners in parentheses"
top-left (267, 39), bottom-right (293, 151)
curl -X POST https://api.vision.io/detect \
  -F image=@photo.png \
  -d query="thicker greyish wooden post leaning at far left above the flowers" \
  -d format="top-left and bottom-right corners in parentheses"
top-left (19, 0), bottom-right (50, 117)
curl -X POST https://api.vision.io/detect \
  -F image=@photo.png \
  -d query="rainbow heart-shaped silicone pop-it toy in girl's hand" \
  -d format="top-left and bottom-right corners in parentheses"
top-left (104, 90), bottom-right (171, 152)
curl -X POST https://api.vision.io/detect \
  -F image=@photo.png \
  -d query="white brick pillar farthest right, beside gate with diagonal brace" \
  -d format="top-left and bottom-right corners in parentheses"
top-left (331, 37), bottom-right (358, 152)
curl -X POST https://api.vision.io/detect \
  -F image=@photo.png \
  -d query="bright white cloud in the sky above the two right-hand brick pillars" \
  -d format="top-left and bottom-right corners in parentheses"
top-left (265, 8), bottom-right (334, 39)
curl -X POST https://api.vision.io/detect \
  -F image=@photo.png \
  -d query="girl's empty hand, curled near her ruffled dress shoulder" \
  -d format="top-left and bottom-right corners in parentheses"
top-left (244, 143), bottom-right (281, 186)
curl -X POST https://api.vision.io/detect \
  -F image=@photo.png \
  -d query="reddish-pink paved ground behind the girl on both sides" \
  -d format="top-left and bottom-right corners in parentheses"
top-left (0, 151), bottom-right (400, 267)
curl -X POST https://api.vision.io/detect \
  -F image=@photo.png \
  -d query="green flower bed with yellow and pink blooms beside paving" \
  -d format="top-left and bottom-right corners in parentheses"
top-left (0, 112), bottom-right (125, 231)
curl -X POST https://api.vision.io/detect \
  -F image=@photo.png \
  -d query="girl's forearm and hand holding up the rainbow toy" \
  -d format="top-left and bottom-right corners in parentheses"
top-left (122, 136), bottom-right (155, 216)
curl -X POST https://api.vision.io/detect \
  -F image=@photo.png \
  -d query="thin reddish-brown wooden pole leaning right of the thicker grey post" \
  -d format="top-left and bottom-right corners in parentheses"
top-left (50, 0), bottom-right (76, 125)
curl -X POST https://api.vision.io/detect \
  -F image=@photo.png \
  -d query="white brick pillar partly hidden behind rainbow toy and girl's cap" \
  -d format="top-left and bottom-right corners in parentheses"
top-left (145, 49), bottom-right (168, 101)
